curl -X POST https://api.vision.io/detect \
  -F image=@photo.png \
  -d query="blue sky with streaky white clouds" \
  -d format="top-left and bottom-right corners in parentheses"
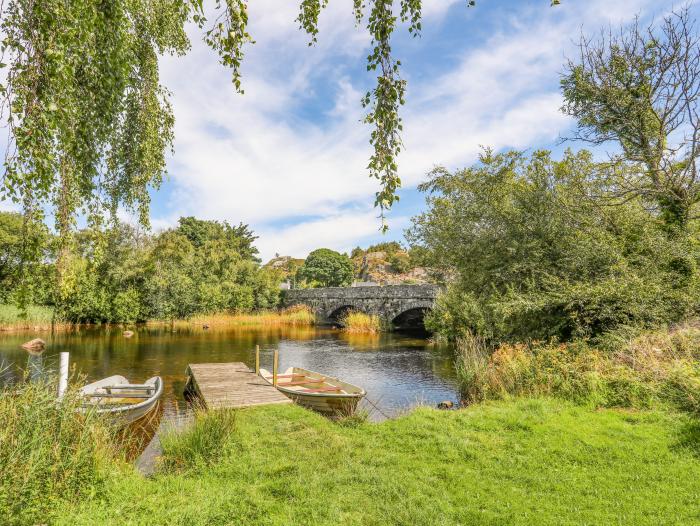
top-left (116, 0), bottom-right (696, 259)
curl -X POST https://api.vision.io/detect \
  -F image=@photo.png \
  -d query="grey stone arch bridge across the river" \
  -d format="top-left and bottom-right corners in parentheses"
top-left (284, 285), bottom-right (440, 329)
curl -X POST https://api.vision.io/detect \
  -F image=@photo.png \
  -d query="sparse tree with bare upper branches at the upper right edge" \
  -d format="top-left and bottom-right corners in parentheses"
top-left (561, 8), bottom-right (700, 230)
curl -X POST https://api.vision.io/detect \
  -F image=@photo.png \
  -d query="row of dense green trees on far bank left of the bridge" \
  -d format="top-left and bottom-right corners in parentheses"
top-left (0, 214), bottom-right (281, 323)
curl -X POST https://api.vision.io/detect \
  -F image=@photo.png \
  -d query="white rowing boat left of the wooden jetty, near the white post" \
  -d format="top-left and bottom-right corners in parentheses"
top-left (80, 374), bottom-right (163, 424)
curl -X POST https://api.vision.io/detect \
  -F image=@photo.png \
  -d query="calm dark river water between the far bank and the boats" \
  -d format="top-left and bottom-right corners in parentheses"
top-left (0, 326), bottom-right (458, 419)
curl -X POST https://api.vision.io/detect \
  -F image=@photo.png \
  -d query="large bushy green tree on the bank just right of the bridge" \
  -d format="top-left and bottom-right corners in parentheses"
top-left (407, 151), bottom-right (700, 342)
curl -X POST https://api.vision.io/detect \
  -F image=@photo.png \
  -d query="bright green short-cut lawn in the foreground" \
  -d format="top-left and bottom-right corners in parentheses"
top-left (61, 399), bottom-right (700, 525)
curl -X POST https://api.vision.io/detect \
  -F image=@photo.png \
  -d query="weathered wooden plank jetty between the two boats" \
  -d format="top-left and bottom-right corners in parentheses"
top-left (187, 362), bottom-right (292, 409)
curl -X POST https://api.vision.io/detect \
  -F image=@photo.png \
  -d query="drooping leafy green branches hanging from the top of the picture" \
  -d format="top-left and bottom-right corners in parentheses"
top-left (0, 0), bottom-right (557, 249)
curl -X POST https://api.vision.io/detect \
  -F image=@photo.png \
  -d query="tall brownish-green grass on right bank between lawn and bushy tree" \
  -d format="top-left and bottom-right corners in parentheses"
top-left (457, 326), bottom-right (700, 414)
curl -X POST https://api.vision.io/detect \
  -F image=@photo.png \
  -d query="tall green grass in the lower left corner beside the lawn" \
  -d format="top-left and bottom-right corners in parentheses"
top-left (0, 383), bottom-right (114, 525)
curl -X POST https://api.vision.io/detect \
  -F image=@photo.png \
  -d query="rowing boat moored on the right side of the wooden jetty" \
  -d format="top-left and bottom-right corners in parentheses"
top-left (260, 367), bottom-right (367, 415)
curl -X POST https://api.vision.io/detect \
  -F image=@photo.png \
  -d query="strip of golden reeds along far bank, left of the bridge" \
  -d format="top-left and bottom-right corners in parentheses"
top-left (156, 305), bottom-right (316, 328)
